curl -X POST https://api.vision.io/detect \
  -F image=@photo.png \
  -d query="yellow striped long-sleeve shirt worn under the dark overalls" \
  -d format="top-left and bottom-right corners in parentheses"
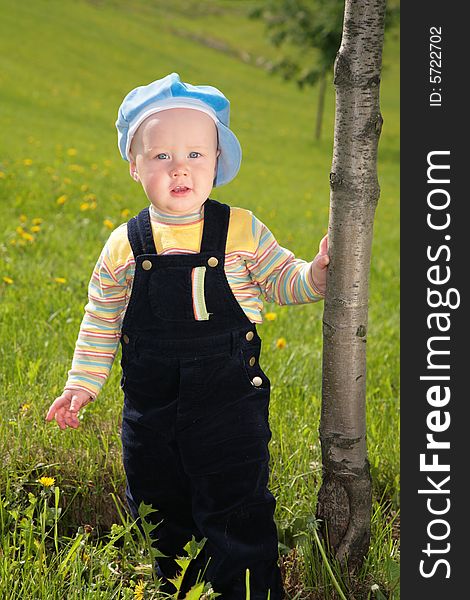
top-left (65, 205), bottom-right (322, 398)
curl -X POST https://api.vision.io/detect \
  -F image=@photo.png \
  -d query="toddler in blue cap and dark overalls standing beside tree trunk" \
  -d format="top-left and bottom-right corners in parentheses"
top-left (46, 73), bottom-right (329, 600)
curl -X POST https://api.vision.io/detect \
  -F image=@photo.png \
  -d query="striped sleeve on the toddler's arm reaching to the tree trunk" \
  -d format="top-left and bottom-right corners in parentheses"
top-left (247, 215), bottom-right (323, 305)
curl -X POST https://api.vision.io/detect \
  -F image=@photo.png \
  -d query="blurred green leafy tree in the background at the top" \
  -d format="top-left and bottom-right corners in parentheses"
top-left (249, 0), bottom-right (399, 140)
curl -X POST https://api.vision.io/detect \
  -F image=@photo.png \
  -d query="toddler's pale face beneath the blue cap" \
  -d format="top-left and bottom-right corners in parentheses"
top-left (130, 108), bottom-right (219, 215)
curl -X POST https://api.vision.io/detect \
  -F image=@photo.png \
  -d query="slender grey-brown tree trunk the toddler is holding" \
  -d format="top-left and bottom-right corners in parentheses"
top-left (317, 0), bottom-right (385, 570)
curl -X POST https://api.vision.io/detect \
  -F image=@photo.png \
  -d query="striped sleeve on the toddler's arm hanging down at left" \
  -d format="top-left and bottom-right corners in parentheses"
top-left (65, 230), bottom-right (135, 399)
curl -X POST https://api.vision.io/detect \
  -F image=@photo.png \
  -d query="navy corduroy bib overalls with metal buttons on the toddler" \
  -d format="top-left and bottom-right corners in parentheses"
top-left (121, 198), bottom-right (283, 600)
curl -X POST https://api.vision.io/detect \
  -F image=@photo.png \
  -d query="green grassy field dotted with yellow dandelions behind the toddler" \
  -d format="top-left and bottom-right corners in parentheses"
top-left (0, 0), bottom-right (399, 599)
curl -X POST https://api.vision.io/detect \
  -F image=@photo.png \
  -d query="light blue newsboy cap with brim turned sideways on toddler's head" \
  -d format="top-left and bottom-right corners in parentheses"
top-left (116, 73), bottom-right (242, 186)
